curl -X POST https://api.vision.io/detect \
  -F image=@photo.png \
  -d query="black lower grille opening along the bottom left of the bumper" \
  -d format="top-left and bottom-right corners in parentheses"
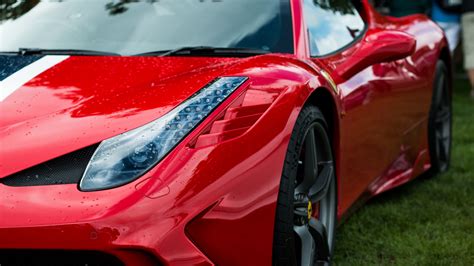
top-left (0, 250), bottom-right (124, 266)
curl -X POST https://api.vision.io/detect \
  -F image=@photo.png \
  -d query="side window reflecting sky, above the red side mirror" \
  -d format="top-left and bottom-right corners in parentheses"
top-left (303, 0), bottom-right (365, 56)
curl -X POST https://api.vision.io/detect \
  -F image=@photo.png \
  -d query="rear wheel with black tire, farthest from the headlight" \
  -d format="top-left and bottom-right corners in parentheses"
top-left (428, 61), bottom-right (452, 176)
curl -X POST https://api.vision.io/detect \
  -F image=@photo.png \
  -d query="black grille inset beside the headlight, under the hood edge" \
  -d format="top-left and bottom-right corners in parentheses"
top-left (0, 145), bottom-right (98, 187)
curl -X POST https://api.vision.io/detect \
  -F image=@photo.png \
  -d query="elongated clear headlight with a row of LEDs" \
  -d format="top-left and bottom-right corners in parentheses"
top-left (79, 77), bottom-right (247, 191)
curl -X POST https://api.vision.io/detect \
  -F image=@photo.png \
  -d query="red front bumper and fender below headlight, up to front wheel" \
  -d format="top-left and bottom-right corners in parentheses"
top-left (0, 76), bottom-right (305, 265)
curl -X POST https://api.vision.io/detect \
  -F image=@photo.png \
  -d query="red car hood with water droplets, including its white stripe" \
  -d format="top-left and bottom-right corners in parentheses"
top-left (0, 56), bottom-right (239, 178)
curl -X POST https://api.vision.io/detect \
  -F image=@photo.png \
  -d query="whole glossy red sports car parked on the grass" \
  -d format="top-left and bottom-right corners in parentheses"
top-left (0, 0), bottom-right (452, 265)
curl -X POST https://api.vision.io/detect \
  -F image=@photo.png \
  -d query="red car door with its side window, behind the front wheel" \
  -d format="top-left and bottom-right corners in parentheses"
top-left (302, 0), bottom-right (420, 211)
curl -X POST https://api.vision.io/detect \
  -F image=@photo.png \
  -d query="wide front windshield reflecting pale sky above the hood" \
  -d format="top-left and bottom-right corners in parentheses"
top-left (0, 0), bottom-right (293, 55)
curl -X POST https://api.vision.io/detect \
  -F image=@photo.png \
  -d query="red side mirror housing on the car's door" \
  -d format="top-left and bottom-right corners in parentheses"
top-left (337, 30), bottom-right (416, 79)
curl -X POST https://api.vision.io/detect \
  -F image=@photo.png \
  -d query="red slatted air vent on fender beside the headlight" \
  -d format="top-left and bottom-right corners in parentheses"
top-left (193, 89), bottom-right (275, 148)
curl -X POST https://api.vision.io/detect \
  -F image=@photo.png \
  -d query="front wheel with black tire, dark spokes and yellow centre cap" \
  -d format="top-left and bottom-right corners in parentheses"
top-left (273, 106), bottom-right (337, 265)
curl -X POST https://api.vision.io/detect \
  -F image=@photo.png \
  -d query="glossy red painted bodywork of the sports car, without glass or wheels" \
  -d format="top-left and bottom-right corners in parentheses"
top-left (0, 0), bottom-right (449, 265)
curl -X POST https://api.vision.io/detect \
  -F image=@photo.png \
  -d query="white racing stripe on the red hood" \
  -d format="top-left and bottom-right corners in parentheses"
top-left (0, 55), bottom-right (69, 102)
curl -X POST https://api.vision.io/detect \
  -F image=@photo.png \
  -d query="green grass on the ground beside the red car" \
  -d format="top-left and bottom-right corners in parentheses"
top-left (334, 80), bottom-right (474, 265)
